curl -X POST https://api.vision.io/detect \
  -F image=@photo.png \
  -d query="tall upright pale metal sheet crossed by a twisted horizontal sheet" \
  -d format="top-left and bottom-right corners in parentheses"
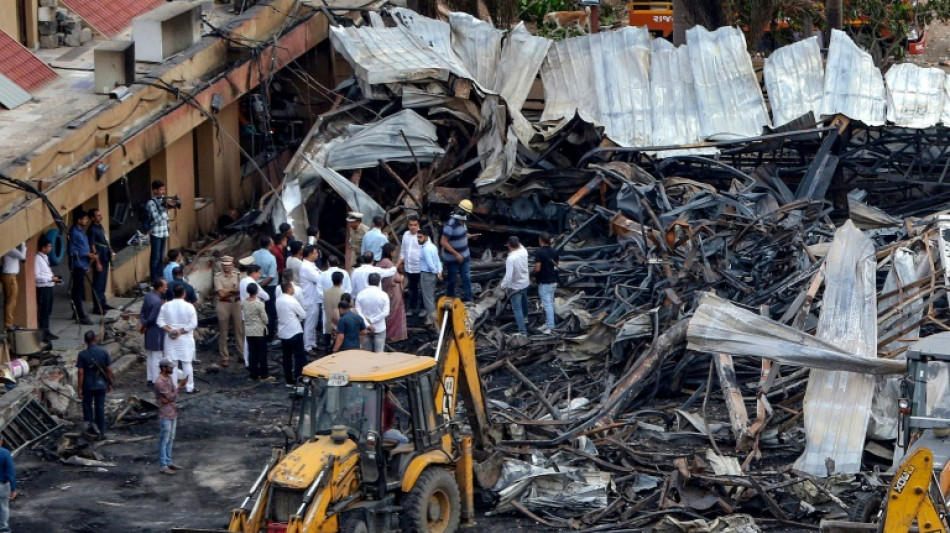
top-left (795, 221), bottom-right (877, 476)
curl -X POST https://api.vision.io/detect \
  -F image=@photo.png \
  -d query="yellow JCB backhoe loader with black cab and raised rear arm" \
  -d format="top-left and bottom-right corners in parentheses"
top-left (173, 298), bottom-right (495, 533)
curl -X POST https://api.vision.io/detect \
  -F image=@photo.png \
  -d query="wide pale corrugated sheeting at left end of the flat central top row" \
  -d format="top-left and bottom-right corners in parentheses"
top-left (541, 27), bottom-right (653, 146)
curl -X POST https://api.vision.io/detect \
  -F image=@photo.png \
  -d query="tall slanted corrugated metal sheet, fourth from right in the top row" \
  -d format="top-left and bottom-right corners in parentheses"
top-left (686, 26), bottom-right (769, 138)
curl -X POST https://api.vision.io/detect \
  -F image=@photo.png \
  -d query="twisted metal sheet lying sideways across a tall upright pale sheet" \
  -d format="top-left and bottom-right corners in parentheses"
top-left (686, 293), bottom-right (905, 376)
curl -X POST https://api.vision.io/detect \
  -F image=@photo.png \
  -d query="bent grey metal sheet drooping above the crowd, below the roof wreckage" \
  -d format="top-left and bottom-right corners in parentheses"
top-left (326, 109), bottom-right (445, 170)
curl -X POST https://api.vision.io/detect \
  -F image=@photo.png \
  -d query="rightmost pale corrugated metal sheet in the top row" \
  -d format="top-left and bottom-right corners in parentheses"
top-left (884, 63), bottom-right (947, 128)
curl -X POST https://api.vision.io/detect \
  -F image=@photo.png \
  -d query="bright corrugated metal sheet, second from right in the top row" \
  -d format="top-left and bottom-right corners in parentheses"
top-left (821, 30), bottom-right (887, 126)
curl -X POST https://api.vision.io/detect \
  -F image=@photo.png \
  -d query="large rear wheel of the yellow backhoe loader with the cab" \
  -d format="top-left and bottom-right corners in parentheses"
top-left (399, 467), bottom-right (461, 533)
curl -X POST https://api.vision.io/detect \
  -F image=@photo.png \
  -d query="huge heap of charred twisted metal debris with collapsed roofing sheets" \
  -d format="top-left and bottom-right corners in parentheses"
top-left (260, 8), bottom-right (950, 531)
